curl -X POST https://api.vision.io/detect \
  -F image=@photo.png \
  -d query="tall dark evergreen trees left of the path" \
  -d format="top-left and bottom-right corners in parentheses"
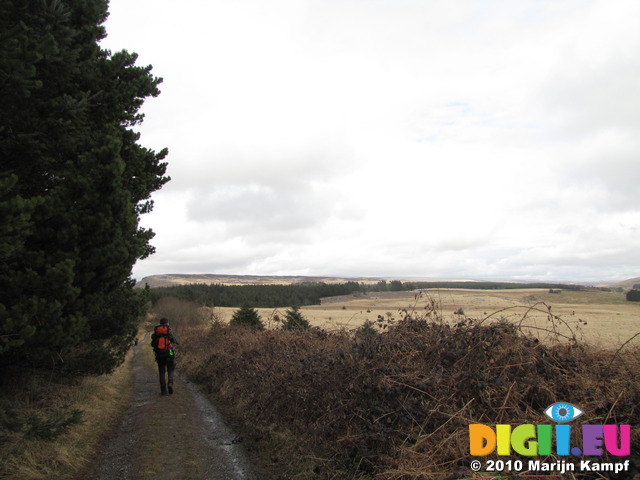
top-left (0, 0), bottom-right (169, 373)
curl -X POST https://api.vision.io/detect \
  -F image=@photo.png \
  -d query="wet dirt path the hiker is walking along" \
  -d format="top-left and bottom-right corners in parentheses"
top-left (88, 341), bottom-right (256, 480)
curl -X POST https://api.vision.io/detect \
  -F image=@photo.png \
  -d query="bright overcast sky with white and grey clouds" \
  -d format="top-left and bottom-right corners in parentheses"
top-left (103, 0), bottom-right (640, 281)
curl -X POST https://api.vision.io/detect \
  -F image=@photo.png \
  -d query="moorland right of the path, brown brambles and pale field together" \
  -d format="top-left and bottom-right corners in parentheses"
top-left (148, 280), bottom-right (640, 480)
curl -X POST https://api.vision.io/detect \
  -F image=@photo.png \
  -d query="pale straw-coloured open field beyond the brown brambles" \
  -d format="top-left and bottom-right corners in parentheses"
top-left (215, 289), bottom-right (640, 348)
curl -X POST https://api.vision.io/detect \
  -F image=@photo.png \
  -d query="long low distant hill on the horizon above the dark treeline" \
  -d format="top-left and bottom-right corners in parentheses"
top-left (136, 273), bottom-right (384, 288)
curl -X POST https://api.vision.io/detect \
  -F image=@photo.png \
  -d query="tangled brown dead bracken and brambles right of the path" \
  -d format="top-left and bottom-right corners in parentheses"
top-left (176, 311), bottom-right (640, 480)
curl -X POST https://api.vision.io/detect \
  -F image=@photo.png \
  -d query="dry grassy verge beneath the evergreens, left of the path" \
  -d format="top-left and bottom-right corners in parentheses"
top-left (0, 344), bottom-right (133, 480)
